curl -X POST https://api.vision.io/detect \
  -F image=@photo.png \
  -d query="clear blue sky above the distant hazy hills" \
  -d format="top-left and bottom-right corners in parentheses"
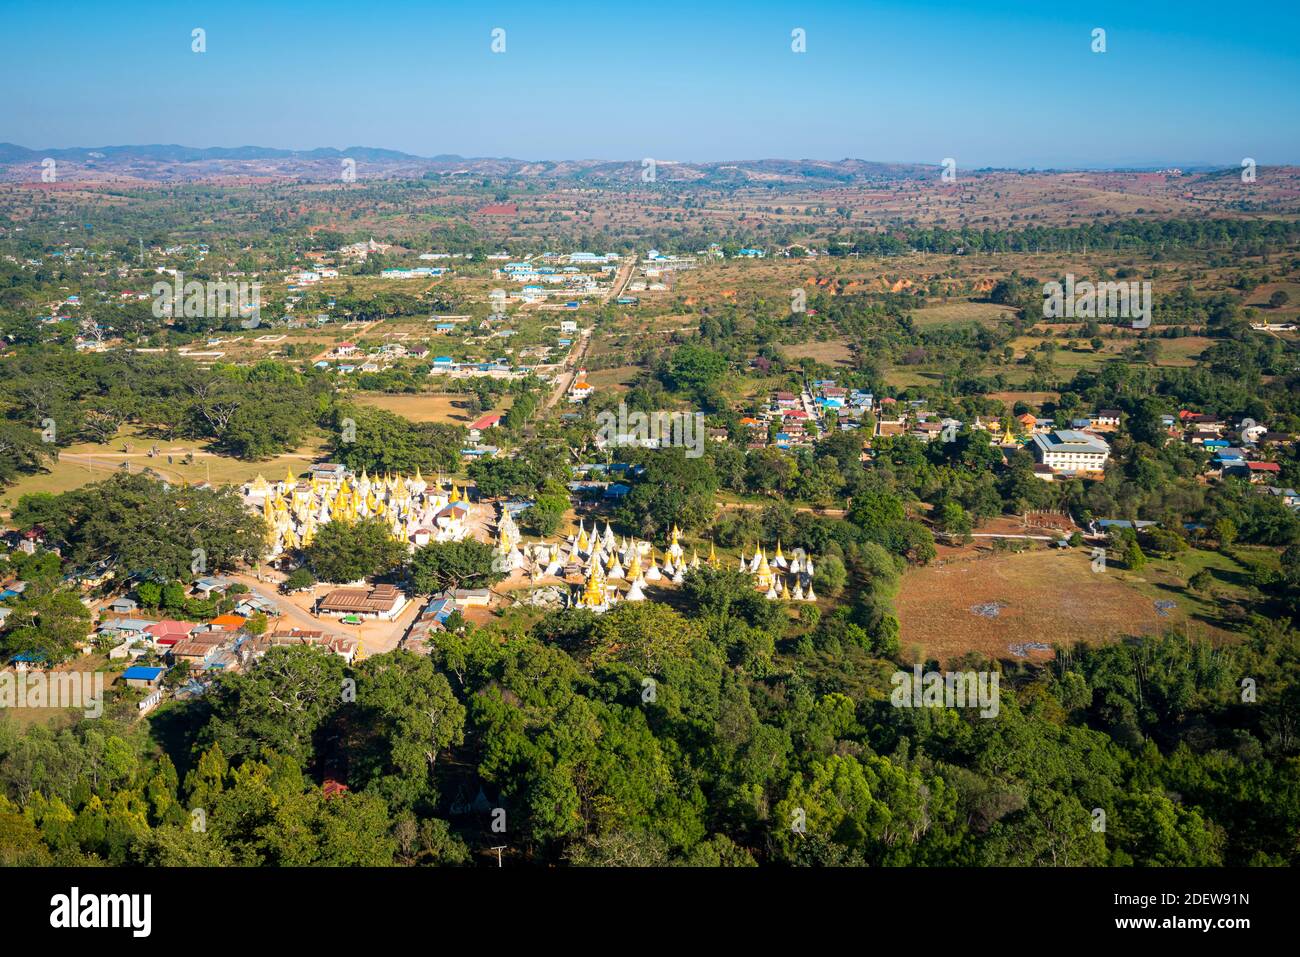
top-left (0, 0), bottom-right (1300, 169)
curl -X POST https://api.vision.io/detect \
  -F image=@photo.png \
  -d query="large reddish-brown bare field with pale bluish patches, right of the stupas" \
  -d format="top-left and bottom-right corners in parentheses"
top-left (898, 547), bottom-right (1229, 663)
